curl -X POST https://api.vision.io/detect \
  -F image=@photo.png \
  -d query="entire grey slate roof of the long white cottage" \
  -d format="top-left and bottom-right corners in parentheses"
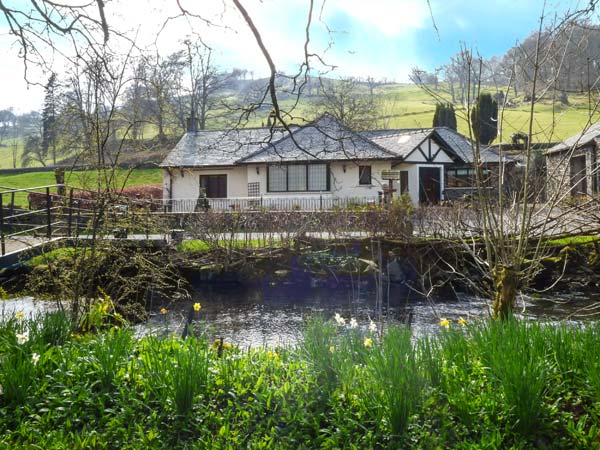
top-left (160, 114), bottom-right (506, 167)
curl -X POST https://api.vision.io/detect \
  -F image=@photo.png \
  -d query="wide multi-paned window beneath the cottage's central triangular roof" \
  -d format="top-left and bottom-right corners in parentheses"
top-left (267, 164), bottom-right (329, 192)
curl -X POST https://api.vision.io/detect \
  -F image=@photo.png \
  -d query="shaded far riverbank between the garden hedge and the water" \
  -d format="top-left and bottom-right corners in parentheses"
top-left (1, 232), bottom-right (600, 321)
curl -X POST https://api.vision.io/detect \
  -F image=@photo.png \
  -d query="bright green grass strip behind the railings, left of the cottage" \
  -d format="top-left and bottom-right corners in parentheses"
top-left (0, 169), bottom-right (162, 207)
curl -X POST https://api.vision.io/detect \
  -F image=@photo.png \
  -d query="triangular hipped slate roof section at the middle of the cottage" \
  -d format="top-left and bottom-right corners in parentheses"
top-left (239, 114), bottom-right (398, 163)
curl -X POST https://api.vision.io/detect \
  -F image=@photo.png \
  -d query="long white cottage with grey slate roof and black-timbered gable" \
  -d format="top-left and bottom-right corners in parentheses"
top-left (161, 114), bottom-right (488, 211)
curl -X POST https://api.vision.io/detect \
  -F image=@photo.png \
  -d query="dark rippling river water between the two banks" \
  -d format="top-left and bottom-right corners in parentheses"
top-left (5, 284), bottom-right (600, 347)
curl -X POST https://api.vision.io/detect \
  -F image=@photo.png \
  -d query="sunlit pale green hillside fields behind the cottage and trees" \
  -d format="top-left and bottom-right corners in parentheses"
top-left (0, 84), bottom-right (600, 169)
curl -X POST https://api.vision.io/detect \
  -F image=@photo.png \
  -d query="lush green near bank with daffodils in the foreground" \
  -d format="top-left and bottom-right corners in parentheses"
top-left (0, 312), bottom-right (600, 449)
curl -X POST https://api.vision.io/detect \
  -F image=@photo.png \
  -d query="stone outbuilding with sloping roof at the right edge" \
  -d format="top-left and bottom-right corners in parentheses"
top-left (546, 122), bottom-right (600, 198)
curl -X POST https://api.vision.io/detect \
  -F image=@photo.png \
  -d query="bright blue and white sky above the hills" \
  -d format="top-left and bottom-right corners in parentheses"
top-left (0, 0), bottom-right (587, 112)
